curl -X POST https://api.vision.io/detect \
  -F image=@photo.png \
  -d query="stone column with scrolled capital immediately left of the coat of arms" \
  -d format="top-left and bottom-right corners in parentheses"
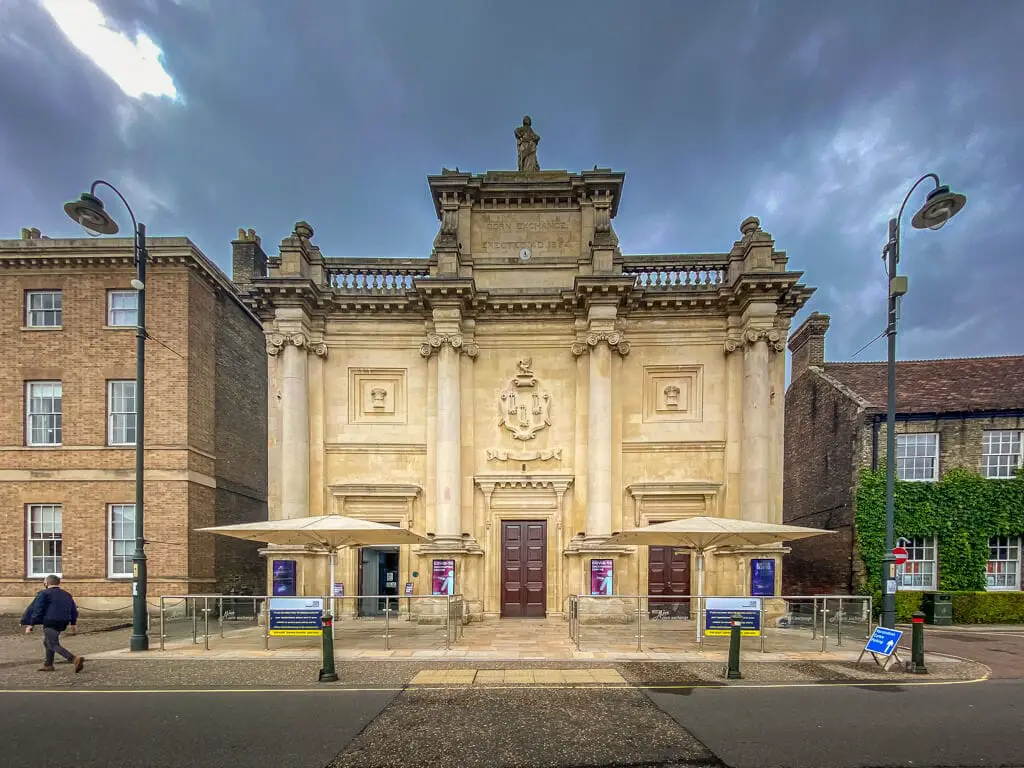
top-left (420, 334), bottom-right (476, 545)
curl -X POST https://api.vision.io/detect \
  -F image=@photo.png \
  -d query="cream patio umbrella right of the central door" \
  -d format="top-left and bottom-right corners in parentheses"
top-left (608, 517), bottom-right (836, 640)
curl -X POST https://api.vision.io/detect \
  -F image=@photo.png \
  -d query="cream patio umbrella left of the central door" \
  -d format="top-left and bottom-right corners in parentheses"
top-left (197, 515), bottom-right (430, 599)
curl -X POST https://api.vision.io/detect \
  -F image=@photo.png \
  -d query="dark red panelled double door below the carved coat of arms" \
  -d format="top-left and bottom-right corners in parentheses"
top-left (501, 520), bottom-right (548, 618)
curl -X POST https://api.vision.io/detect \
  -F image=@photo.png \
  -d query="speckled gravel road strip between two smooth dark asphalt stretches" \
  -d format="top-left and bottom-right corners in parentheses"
top-left (331, 688), bottom-right (723, 768)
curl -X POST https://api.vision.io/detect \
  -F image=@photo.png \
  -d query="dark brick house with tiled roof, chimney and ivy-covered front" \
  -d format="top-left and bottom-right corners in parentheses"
top-left (783, 312), bottom-right (1024, 595)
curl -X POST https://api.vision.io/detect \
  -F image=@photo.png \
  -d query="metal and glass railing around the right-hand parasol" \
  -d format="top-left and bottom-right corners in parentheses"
top-left (566, 595), bottom-right (873, 653)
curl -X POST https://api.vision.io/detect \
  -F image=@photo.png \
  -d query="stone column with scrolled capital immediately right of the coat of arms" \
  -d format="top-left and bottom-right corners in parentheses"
top-left (572, 332), bottom-right (630, 539)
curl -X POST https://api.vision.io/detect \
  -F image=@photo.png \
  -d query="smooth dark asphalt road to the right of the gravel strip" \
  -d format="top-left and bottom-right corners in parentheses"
top-left (648, 680), bottom-right (1024, 768)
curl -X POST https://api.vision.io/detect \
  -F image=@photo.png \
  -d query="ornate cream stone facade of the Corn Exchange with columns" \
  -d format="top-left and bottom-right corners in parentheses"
top-left (233, 159), bottom-right (812, 615)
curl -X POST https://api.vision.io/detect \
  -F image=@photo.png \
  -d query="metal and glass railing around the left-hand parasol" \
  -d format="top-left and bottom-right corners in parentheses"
top-left (159, 594), bottom-right (468, 650)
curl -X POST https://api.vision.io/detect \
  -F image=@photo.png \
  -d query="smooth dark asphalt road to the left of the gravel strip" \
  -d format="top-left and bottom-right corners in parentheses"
top-left (0, 691), bottom-right (395, 768)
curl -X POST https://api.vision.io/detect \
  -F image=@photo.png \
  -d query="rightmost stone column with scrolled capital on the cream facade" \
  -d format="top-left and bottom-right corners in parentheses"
top-left (739, 329), bottom-right (781, 522)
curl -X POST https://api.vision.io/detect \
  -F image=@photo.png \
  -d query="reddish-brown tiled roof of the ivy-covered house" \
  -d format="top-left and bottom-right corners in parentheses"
top-left (824, 355), bottom-right (1024, 414)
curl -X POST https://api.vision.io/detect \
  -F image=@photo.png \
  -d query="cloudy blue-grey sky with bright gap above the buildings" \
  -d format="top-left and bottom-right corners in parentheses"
top-left (0, 0), bottom-right (1024, 359)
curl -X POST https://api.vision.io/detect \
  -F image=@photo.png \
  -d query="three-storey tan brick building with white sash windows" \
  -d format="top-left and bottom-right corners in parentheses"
top-left (0, 229), bottom-right (266, 611)
